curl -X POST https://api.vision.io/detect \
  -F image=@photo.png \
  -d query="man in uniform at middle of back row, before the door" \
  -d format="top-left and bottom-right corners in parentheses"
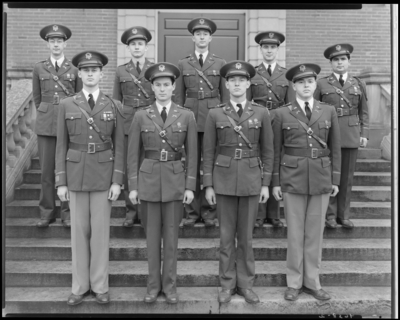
top-left (175, 18), bottom-right (229, 226)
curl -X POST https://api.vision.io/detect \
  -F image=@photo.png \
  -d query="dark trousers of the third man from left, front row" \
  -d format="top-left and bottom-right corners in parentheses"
top-left (216, 194), bottom-right (260, 290)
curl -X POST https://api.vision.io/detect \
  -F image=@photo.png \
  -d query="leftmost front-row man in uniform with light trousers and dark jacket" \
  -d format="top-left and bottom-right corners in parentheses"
top-left (56, 51), bottom-right (124, 305)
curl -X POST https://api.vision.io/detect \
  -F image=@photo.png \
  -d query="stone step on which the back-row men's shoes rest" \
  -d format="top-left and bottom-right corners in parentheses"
top-left (6, 218), bottom-right (391, 239)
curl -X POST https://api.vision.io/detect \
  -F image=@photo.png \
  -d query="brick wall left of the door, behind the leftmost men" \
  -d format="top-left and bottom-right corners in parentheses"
top-left (4, 5), bottom-right (117, 94)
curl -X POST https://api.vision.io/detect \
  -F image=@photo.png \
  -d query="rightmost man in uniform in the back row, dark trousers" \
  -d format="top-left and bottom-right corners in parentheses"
top-left (314, 43), bottom-right (369, 229)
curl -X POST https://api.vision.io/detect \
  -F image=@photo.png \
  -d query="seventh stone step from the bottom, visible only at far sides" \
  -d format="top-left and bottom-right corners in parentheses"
top-left (23, 170), bottom-right (391, 186)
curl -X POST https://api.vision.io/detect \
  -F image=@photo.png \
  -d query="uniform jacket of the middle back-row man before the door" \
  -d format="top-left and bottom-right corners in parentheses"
top-left (174, 52), bottom-right (229, 132)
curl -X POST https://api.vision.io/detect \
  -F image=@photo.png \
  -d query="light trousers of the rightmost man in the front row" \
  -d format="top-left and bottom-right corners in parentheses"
top-left (283, 192), bottom-right (330, 290)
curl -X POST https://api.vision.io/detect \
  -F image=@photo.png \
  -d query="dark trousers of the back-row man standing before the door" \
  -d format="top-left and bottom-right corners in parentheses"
top-left (185, 132), bottom-right (217, 220)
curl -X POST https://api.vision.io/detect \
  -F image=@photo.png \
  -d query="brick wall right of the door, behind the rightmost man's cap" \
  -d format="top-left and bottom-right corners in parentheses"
top-left (286, 4), bottom-right (391, 76)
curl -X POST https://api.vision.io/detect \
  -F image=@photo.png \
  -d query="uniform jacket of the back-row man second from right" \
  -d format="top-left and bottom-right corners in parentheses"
top-left (247, 63), bottom-right (296, 119)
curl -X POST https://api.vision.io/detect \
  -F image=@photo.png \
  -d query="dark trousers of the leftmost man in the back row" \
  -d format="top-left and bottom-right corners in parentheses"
top-left (37, 135), bottom-right (70, 221)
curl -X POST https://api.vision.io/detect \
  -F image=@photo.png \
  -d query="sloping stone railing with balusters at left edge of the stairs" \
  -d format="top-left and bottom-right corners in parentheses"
top-left (6, 79), bottom-right (37, 203)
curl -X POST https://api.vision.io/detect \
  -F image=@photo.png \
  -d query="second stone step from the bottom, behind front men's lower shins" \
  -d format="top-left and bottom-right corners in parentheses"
top-left (5, 261), bottom-right (391, 287)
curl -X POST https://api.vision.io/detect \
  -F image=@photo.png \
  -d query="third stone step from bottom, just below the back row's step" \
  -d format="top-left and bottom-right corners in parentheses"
top-left (6, 238), bottom-right (391, 261)
